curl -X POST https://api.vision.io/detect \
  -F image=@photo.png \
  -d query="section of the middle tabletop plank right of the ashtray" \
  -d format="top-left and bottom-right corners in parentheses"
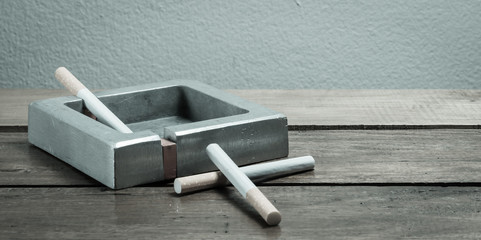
top-left (282, 129), bottom-right (481, 184)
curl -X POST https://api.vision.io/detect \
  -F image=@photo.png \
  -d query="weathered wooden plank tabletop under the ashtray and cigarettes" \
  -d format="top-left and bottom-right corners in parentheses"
top-left (0, 89), bottom-right (481, 239)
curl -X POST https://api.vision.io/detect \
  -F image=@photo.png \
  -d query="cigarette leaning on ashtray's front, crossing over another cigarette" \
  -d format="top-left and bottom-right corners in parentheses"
top-left (206, 143), bottom-right (281, 225)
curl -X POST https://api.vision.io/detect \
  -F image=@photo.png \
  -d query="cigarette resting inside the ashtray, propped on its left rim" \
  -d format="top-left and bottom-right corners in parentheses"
top-left (55, 67), bottom-right (132, 133)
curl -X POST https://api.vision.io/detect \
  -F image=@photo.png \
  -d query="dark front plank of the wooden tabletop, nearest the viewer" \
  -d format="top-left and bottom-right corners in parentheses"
top-left (0, 186), bottom-right (481, 239)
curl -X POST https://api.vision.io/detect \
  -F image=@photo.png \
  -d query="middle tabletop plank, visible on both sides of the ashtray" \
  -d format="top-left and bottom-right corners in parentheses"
top-left (0, 129), bottom-right (481, 186)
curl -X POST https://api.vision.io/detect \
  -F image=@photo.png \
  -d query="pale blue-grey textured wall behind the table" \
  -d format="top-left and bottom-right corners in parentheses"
top-left (0, 0), bottom-right (481, 89)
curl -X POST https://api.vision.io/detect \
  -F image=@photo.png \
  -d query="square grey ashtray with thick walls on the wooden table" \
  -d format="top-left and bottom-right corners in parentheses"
top-left (28, 81), bottom-right (288, 189)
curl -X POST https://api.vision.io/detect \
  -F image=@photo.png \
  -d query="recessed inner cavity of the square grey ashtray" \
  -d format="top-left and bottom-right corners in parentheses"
top-left (65, 86), bottom-right (249, 137)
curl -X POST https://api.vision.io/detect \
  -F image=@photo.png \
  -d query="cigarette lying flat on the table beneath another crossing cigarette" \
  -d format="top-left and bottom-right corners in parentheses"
top-left (174, 156), bottom-right (315, 194)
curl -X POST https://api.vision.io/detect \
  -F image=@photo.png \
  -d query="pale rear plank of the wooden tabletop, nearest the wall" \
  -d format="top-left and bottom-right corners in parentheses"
top-left (0, 89), bottom-right (481, 129)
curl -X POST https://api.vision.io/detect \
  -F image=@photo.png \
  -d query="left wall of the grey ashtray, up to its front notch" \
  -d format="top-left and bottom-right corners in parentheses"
top-left (28, 97), bottom-right (163, 189)
